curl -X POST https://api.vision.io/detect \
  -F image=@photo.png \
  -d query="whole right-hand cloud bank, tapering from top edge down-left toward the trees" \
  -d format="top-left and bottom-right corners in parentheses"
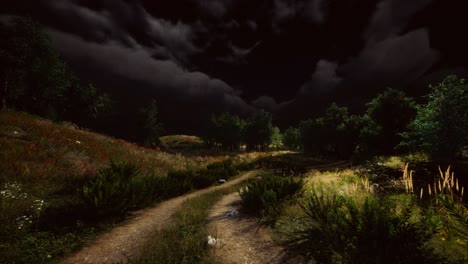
top-left (272, 0), bottom-right (440, 122)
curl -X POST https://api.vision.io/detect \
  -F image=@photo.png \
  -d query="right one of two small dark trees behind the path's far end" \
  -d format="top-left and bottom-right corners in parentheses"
top-left (245, 110), bottom-right (274, 150)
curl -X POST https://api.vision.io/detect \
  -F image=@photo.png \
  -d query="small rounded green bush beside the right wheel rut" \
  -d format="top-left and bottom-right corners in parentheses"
top-left (239, 174), bottom-right (303, 223)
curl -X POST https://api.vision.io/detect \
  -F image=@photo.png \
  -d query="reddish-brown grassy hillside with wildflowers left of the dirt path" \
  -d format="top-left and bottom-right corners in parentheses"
top-left (0, 111), bottom-right (263, 263)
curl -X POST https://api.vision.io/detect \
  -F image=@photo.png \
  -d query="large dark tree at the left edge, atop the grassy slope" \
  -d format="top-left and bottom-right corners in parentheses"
top-left (0, 15), bottom-right (70, 118)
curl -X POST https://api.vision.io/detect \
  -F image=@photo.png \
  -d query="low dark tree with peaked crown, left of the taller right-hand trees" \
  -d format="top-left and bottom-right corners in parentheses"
top-left (300, 104), bottom-right (361, 158)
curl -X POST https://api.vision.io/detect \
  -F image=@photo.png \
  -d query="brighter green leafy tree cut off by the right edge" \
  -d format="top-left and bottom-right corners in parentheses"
top-left (400, 75), bottom-right (468, 161)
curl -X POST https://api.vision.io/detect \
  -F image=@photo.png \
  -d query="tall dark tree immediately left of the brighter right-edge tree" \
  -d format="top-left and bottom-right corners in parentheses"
top-left (360, 88), bottom-right (416, 155)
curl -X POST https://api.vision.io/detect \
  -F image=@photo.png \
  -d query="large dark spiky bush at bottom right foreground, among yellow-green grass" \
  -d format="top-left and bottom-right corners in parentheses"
top-left (285, 188), bottom-right (437, 263)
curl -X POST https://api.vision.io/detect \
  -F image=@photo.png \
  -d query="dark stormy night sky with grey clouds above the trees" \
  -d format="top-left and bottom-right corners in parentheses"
top-left (1, 0), bottom-right (468, 135)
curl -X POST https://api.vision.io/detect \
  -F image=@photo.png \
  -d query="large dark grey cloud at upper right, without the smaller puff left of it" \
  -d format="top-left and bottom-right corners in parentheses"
top-left (332, 0), bottom-right (439, 89)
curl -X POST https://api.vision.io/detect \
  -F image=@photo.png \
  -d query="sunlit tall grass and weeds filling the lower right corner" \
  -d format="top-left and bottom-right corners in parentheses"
top-left (276, 164), bottom-right (468, 263)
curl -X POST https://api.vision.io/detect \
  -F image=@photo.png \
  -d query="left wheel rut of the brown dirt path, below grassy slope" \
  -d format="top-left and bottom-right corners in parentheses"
top-left (61, 171), bottom-right (255, 264)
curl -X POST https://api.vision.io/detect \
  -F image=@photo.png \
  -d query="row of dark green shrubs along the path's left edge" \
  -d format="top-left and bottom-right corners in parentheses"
top-left (82, 159), bottom-right (238, 218)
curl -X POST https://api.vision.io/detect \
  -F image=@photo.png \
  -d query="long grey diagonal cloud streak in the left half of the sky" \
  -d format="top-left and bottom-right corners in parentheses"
top-left (49, 30), bottom-right (252, 113)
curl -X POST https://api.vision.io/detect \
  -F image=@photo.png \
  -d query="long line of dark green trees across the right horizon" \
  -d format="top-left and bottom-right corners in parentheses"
top-left (205, 75), bottom-right (468, 160)
